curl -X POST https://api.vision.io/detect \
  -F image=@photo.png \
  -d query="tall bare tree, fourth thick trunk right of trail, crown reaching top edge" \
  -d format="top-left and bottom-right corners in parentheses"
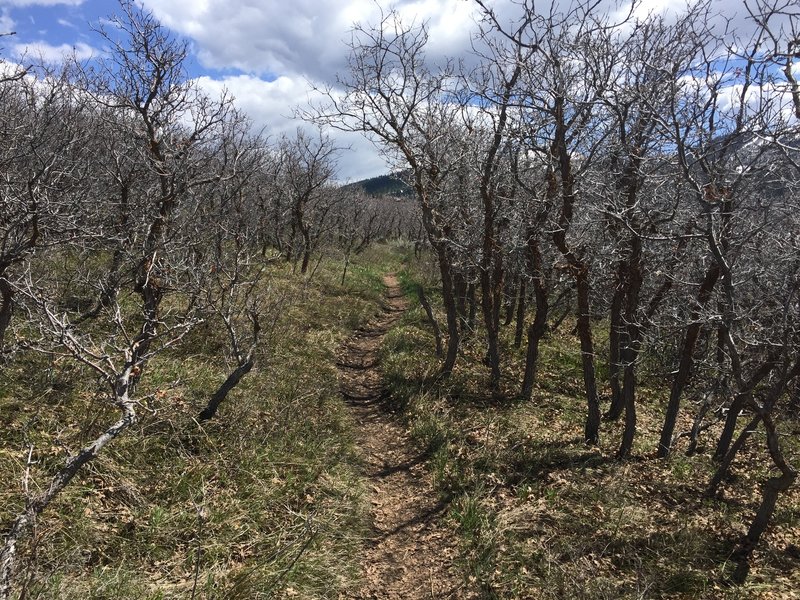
top-left (486, 2), bottom-right (624, 444)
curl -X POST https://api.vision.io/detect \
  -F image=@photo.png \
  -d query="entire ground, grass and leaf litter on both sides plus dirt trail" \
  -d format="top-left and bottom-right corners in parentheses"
top-left (6, 246), bottom-right (800, 600)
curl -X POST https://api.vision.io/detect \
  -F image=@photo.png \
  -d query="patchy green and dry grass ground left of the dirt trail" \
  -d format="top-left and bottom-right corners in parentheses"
top-left (0, 248), bottom-right (400, 600)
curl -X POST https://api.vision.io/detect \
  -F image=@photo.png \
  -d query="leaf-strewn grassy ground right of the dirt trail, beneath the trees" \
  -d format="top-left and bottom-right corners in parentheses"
top-left (383, 263), bottom-right (800, 599)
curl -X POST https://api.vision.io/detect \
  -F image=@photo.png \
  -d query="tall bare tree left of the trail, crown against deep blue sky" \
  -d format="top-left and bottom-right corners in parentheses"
top-left (84, 0), bottom-right (238, 370)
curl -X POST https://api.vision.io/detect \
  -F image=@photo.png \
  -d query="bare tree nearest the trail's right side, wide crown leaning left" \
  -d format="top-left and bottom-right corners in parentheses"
top-left (305, 12), bottom-right (463, 374)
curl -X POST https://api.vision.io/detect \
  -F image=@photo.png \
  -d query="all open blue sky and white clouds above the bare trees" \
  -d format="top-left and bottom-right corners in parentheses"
top-left (0, 0), bottom-right (792, 181)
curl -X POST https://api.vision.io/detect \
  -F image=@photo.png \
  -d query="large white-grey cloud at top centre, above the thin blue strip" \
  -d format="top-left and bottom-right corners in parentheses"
top-left (144, 0), bottom-right (482, 81)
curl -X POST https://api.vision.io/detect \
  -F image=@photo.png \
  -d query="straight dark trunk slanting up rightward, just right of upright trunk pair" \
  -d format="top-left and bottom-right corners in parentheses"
top-left (658, 263), bottom-right (720, 458)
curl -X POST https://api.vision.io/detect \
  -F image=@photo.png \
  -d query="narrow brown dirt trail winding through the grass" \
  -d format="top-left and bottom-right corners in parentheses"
top-left (339, 275), bottom-right (469, 600)
